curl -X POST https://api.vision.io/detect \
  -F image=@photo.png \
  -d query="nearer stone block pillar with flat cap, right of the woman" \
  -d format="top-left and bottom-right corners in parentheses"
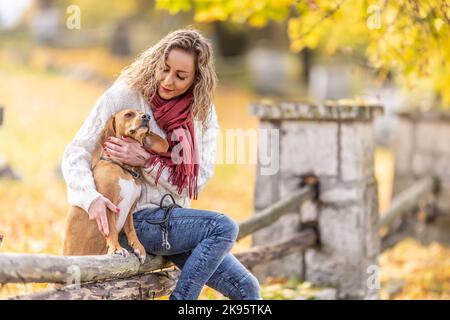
top-left (250, 102), bottom-right (383, 299)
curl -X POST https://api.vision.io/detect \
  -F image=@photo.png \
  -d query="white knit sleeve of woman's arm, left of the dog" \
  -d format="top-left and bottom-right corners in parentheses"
top-left (61, 91), bottom-right (115, 212)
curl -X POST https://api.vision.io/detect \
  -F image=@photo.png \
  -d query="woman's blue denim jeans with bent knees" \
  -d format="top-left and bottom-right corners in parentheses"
top-left (133, 208), bottom-right (262, 300)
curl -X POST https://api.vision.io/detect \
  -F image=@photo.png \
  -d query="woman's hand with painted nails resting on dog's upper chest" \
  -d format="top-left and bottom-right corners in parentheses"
top-left (103, 137), bottom-right (150, 167)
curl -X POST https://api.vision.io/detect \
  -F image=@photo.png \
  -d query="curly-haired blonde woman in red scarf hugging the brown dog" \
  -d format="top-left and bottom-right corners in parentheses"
top-left (62, 30), bottom-right (261, 300)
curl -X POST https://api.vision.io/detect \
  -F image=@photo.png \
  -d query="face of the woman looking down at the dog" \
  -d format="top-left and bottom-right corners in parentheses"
top-left (158, 48), bottom-right (195, 100)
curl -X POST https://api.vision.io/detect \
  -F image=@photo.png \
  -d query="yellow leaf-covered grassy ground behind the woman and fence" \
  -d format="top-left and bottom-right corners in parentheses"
top-left (0, 50), bottom-right (450, 299)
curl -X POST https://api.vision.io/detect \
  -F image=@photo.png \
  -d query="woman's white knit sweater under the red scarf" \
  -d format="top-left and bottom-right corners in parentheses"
top-left (61, 80), bottom-right (220, 212)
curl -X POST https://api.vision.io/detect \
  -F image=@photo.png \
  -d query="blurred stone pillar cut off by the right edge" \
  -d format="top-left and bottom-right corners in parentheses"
top-left (391, 112), bottom-right (450, 245)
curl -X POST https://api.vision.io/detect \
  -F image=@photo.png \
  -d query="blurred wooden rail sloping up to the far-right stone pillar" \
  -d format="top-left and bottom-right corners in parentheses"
top-left (378, 176), bottom-right (437, 228)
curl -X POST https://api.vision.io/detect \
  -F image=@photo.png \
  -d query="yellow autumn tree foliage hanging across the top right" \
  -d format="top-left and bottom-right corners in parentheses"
top-left (156, 0), bottom-right (450, 107)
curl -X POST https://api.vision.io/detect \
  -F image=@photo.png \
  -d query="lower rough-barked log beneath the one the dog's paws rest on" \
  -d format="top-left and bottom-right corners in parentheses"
top-left (8, 270), bottom-right (179, 300)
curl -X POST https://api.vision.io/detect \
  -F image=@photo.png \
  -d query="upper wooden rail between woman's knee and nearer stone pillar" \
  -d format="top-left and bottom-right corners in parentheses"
top-left (237, 186), bottom-right (315, 240)
